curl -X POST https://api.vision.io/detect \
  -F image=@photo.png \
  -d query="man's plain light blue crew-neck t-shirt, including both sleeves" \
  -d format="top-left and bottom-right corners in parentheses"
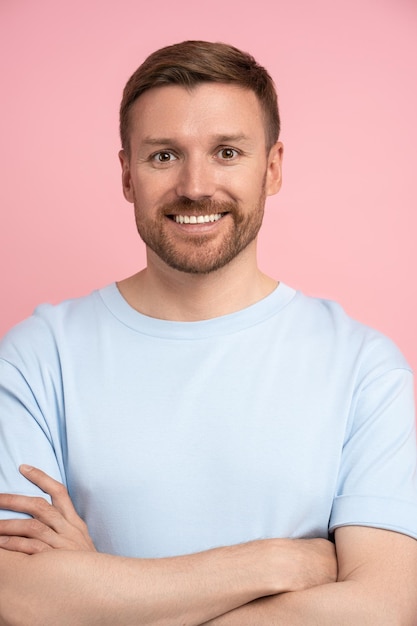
top-left (0, 284), bottom-right (417, 557)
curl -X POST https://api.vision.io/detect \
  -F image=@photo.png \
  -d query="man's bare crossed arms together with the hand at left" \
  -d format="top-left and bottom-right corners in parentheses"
top-left (0, 468), bottom-right (417, 626)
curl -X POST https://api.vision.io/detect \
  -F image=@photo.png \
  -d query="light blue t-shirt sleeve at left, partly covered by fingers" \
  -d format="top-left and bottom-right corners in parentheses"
top-left (0, 316), bottom-right (65, 518)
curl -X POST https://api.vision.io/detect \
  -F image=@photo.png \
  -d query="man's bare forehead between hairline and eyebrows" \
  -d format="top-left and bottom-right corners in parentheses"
top-left (130, 83), bottom-right (265, 140)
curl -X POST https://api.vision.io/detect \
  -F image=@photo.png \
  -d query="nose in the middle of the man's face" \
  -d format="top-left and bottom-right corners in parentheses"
top-left (176, 158), bottom-right (216, 201)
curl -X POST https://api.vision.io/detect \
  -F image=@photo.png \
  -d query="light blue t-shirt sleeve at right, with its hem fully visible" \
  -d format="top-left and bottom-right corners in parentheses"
top-left (329, 367), bottom-right (417, 538)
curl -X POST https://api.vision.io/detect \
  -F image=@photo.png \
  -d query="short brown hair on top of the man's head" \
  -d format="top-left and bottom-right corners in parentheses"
top-left (120, 41), bottom-right (280, 154)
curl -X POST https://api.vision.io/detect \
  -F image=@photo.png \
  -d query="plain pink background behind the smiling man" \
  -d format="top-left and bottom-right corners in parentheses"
top-left (0, 0), bottom-right (417, 390)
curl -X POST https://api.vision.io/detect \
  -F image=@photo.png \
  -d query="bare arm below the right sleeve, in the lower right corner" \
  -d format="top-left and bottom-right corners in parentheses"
top-left (201, 526), bottom-right (417, 626)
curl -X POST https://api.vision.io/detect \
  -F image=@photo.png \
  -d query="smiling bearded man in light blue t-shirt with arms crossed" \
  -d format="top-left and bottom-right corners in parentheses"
top-left (0, 42), bottom-right (417, 626)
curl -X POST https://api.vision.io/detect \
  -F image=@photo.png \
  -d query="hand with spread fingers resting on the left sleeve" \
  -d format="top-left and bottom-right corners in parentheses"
top-left (0, 465), bottom-right (96, 554)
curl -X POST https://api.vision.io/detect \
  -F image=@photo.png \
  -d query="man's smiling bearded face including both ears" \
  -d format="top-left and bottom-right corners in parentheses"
top-left (120, 83), bottom-right (282, 273)
